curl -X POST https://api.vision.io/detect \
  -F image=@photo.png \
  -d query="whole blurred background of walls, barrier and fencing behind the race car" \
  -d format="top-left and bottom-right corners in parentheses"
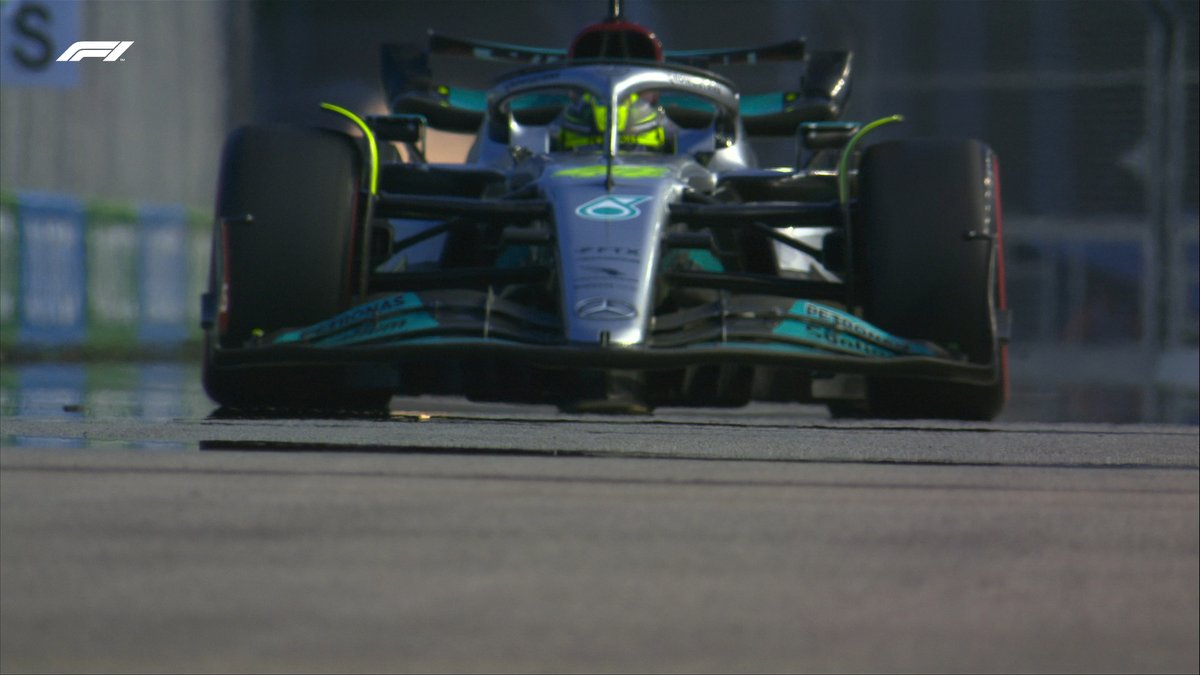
top-left (0, 0), bottom-right (1200, 424)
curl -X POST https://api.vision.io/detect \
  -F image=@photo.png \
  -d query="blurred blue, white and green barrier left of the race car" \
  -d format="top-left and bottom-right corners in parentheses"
top-left (0, 192), bottom-right (210, 350)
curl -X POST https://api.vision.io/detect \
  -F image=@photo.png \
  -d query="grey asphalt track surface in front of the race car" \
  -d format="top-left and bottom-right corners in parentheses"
top-left (0, 400), bottom-right (1200, 673)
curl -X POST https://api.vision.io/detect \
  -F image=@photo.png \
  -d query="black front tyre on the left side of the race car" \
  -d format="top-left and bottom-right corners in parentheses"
top-left (204, 126), bottom-right (390, 408)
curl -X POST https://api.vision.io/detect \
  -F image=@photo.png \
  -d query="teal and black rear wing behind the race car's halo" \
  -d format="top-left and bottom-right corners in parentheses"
top-left (380, 31), bottom-right (852, 136)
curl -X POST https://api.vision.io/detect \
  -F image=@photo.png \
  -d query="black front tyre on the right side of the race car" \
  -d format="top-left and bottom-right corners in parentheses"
top-left (854, 139), bottom-right (1008, 419)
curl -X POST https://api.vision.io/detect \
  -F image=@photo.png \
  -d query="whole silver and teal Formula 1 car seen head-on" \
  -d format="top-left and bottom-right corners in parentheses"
top-left (202, 0), bottom-right (1008, 419)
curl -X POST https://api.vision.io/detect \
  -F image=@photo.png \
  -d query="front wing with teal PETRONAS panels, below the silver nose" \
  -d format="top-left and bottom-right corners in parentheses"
top-left (211, 291), bottom-right (996, 384)
